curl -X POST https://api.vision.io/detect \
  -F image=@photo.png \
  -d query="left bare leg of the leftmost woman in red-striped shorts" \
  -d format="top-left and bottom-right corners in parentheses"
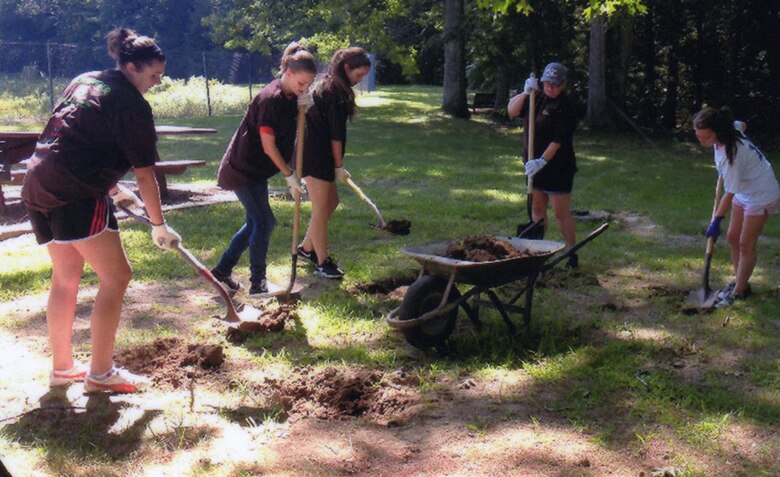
top-left (46, 243), bottom-right (84, 370)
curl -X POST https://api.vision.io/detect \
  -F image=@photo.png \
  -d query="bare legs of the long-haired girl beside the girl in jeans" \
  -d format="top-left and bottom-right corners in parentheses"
top-left (303, 176), bottom-right (339, 264)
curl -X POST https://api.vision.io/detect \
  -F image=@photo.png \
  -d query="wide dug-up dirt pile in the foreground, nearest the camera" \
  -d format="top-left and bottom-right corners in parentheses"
top-left (260, 367), bottom-right (420, 425)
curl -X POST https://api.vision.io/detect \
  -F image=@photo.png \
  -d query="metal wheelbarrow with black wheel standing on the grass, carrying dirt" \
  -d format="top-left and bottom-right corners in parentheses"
top-left (385, 223), bottom-right (609, 349)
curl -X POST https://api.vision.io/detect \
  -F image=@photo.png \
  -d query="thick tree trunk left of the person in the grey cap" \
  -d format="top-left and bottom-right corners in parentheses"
top-left (441, 0), bottom-right (469, 118)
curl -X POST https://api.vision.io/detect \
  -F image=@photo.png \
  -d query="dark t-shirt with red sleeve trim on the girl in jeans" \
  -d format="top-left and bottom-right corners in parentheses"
top-left (217, 79), bottom-right (298, 190)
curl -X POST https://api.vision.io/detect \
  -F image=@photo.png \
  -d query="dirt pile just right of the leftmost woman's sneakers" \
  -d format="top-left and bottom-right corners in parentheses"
top-left (114, 338), bottom-right (225, 388)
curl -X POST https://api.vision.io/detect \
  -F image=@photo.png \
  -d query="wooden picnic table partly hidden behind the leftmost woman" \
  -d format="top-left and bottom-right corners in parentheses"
top-left (0, 125), bottom-right (217, 215)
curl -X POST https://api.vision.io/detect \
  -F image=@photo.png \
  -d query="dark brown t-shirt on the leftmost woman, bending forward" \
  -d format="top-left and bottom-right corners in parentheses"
top-left (22, 70), bottom-right (159, 212)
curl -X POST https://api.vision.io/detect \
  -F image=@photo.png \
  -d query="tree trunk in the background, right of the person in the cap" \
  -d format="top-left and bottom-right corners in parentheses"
top-left (585, 15), bottom-right (610, 128)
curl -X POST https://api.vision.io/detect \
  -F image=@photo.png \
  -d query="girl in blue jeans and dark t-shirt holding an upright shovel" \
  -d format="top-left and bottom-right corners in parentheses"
top-left (211, 43), bottom-right (317, 296)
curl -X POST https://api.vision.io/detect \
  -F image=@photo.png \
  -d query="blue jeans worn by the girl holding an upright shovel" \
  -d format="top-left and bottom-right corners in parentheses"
top-left (214, 181), bottom-right (276, 283)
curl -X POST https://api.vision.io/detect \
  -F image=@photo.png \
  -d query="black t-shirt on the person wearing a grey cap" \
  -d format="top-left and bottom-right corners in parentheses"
top-left (520, 91), bottom-right (577, 178)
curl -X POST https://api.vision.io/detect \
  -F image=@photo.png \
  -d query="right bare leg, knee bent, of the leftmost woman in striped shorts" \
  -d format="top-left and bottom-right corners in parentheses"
top-left (73, 232), bottom-right (132, 375)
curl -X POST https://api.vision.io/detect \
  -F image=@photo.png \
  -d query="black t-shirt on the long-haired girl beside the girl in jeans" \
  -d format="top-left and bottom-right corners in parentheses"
top-left (303, 80), bottom-right (349, 180)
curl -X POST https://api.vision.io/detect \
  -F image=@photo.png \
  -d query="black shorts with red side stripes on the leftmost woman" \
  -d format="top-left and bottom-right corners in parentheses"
top-left (30, 196), bottom-right (119, 245)
